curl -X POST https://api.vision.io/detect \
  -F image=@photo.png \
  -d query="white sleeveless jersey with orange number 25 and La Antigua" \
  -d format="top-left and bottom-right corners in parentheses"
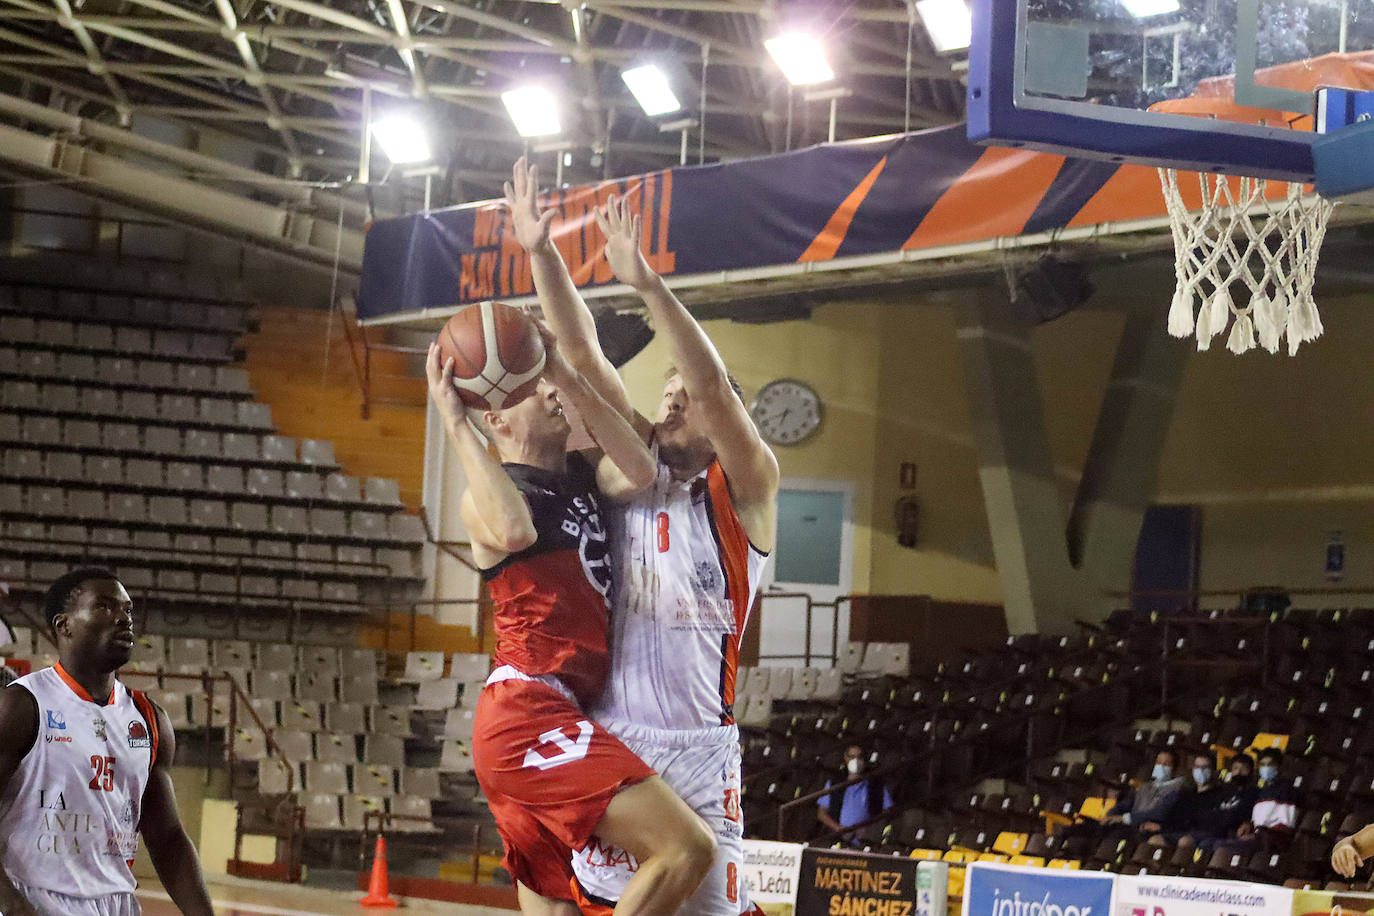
top-left (0, 665), bottom-right (158, 897)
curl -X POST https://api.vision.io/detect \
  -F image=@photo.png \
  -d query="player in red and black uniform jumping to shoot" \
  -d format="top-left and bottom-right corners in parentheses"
top-left (427, 321), bottom-right (714, 916)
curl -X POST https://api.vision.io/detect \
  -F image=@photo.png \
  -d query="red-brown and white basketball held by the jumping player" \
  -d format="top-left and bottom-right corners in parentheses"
top-left (438, 302), bottom-right (544, 411)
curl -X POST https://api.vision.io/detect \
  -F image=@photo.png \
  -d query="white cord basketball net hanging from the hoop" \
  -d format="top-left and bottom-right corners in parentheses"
top-left (1160, 169), bottom-right (1331, 356)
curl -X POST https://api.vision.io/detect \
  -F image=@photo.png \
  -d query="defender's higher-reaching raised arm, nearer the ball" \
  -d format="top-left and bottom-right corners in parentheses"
top-left (506, 157), bottom-right (649, 435)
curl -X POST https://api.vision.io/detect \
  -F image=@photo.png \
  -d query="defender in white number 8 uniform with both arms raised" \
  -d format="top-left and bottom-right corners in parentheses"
top-left (506, 159), bottom-right (779, 916)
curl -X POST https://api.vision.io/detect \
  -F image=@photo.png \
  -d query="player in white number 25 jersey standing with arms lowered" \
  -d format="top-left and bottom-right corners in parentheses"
top-left (0, 569), bottom-right (214, 916)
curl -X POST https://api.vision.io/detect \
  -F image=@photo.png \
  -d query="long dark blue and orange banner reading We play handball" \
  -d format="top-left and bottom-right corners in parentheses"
top-left (359, 124), bottom-right (1165, 319)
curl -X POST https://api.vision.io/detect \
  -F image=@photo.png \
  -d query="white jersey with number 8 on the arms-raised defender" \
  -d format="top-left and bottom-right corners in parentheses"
top-left (594, 461), bottom-right (768, 729)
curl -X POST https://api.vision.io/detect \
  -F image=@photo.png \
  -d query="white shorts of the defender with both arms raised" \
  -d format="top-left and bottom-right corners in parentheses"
top-left (573, 720), bottom-right (750, 916)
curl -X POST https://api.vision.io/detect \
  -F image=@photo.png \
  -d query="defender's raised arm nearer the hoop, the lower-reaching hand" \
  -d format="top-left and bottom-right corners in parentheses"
top-left (596, 198), bottom-right (779, 551)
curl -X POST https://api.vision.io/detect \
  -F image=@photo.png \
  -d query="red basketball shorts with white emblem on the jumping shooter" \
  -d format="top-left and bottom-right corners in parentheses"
top-left (473, 677), bottom-right (654, 900)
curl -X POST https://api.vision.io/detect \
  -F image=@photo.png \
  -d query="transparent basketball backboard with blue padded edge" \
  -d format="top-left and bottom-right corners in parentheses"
top-left (969, 0), bottom-right (1374, 183)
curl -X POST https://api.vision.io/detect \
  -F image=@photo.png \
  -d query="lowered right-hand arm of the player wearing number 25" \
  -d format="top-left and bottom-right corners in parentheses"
top-left (140, 707), bottom-right (214, 916)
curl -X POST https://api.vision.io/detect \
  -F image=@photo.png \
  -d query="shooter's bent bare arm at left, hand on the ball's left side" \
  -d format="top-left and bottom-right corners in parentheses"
top-left (425, 343), bottom-right (539, 567)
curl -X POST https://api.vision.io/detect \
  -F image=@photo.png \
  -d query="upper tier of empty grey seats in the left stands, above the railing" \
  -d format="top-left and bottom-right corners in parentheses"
top-left (0, 286), bottom-right (425, 614)
